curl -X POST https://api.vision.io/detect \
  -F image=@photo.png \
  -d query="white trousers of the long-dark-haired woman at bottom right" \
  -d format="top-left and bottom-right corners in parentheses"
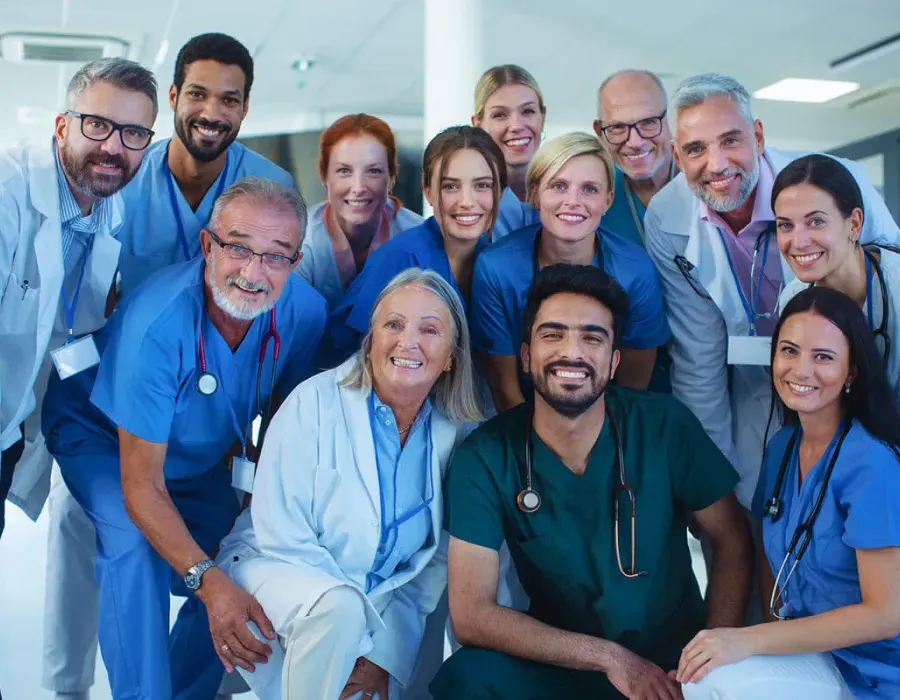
top-left (681, 654), bottom-right (853, 700)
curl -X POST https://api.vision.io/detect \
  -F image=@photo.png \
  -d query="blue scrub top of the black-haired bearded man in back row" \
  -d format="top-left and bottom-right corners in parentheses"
top-left (116, 139), bottom-right (297, 297)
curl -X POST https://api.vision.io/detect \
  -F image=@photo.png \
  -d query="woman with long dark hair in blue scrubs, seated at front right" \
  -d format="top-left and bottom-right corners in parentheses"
top-left (677, 286), bottom-right (900, 700)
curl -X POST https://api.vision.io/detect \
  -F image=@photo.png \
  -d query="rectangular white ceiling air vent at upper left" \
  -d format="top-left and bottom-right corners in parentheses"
top-left (0, 32), bottom-right (130, 63)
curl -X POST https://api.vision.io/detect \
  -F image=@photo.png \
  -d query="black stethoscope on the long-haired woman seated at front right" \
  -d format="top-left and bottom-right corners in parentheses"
top-left (763, 420), bottom-right (852, 620)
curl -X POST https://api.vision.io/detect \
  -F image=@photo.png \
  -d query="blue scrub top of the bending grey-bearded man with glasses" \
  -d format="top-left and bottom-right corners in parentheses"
top-left (44, 257), bottom-right (326, 479)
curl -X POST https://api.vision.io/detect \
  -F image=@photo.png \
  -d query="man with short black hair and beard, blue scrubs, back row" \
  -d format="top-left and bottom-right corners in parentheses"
top-left (119, 34), bottom-right (295, 296)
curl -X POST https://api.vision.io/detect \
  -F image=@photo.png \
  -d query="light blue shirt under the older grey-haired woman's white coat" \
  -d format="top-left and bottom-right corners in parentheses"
top-left (366, 391), bottom-right (434, 593)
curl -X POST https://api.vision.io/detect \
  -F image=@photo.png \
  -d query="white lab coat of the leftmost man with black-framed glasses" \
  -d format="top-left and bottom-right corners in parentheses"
top-left (0, 141), bottom-right (122, 519)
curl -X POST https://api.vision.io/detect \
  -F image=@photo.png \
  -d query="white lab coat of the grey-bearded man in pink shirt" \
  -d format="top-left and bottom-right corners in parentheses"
top-left (644, 148), bottom-right (900, 508)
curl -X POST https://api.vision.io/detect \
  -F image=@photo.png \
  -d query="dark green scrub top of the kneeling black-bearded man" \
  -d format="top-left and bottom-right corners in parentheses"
top-left (445, 387), bottom-right (738, 670)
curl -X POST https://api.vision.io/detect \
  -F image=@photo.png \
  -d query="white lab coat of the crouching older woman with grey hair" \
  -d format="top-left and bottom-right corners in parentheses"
top-left (217, 358), bottom-right (466, 700)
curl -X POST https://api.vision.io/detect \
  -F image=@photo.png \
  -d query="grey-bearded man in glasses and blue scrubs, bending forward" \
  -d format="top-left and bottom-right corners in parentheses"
top-left (44, 178), bottom-right (326, 700)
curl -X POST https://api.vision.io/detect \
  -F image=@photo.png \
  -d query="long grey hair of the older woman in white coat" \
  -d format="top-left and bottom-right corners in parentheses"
top-left (341, 267), bottom-right (482, 423)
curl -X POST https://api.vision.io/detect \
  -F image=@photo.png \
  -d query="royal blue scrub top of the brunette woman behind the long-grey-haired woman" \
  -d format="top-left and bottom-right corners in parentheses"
top-left (328, 216), bottom-right (481, 364)
